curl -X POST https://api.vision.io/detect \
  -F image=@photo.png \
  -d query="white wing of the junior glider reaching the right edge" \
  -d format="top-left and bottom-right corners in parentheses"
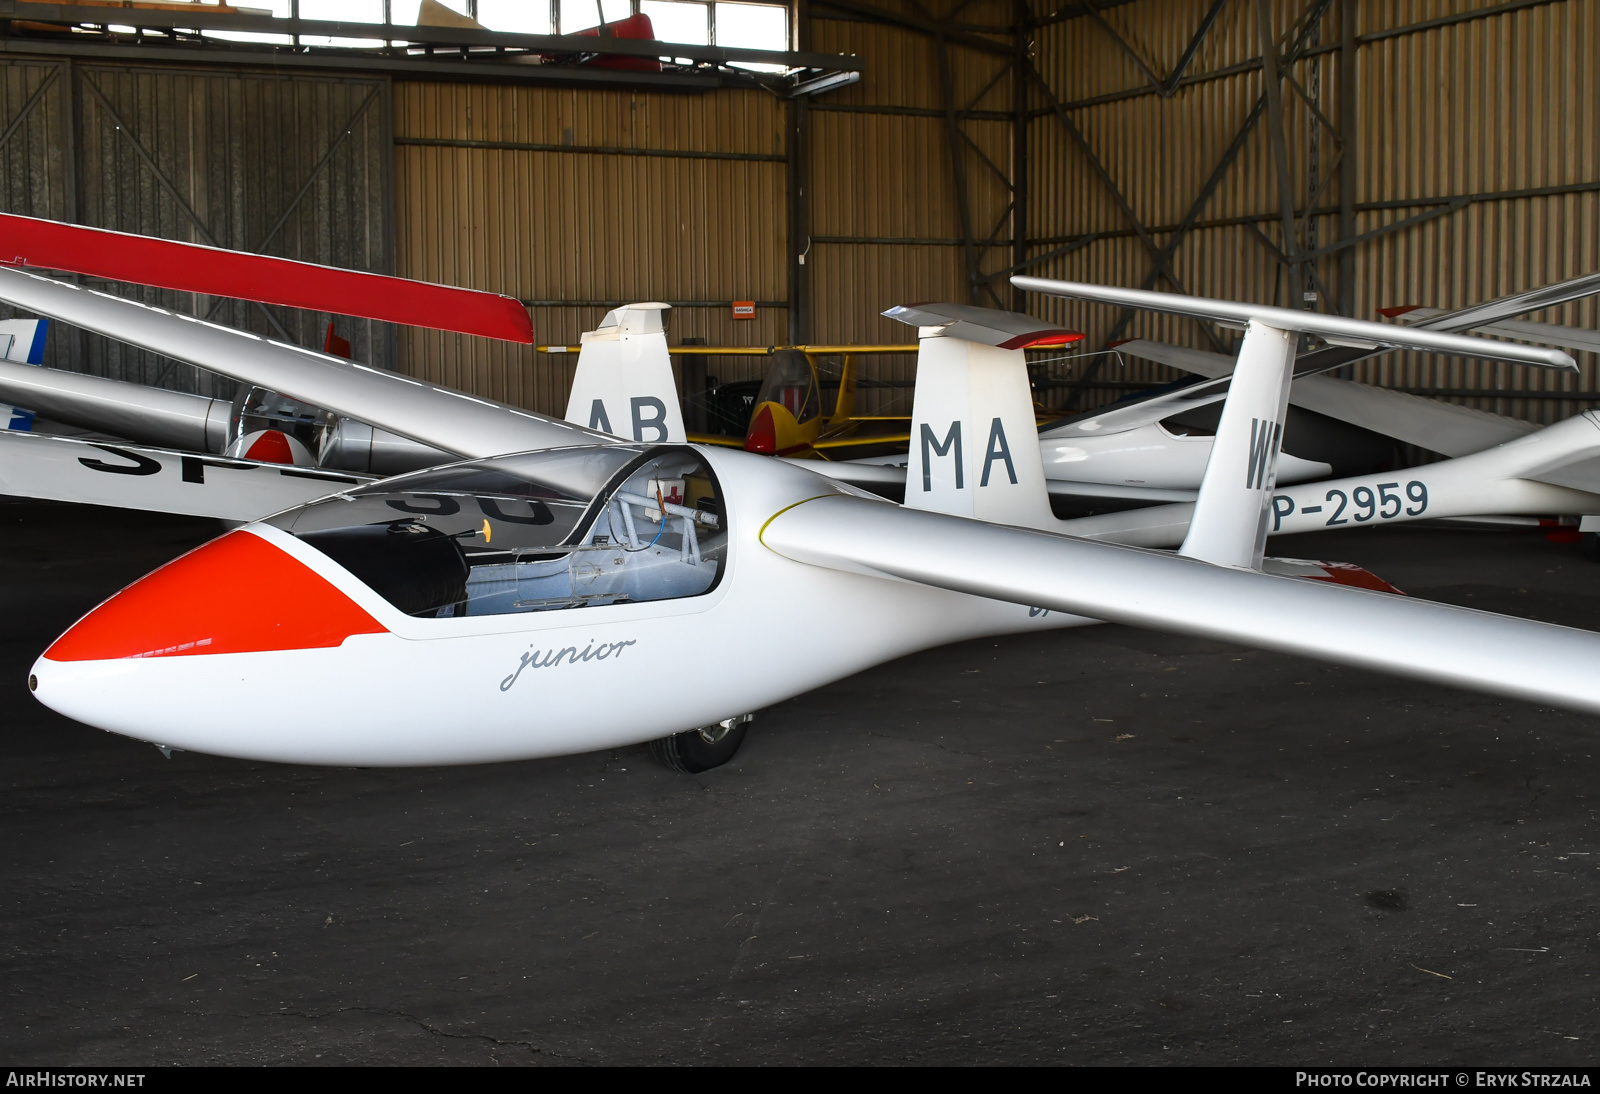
top-left (762, 496), bottom-right (1600, 713)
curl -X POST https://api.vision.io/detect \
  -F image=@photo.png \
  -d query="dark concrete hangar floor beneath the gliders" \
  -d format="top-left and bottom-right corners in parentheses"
top-left (0, 502), bottom-right (1600, 1064)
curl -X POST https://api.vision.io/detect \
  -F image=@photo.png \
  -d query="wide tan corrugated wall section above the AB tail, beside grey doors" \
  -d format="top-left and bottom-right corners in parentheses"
top-left (395, 83), bottom-right (789, 413)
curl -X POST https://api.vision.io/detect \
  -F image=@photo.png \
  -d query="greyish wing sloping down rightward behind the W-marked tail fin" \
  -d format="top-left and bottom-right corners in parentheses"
top-left (1117, 332), bottom-right (1539, 456)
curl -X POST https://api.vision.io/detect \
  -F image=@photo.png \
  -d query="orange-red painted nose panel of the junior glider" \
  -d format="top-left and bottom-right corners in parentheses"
top-left (45, 531), bottom-right (386, 662)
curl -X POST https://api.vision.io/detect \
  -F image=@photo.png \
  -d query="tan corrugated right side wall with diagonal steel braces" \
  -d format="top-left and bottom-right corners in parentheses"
top-left (1030, 0), bottom-right (1600, 421)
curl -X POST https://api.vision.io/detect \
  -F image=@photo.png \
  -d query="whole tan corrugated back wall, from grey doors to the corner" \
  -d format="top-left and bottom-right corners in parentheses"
top-left (395, 8), bottom-right (1011, 413)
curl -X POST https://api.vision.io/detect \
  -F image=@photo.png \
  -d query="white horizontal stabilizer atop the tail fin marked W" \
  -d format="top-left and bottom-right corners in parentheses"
top-left (1011, 277), bottom-right (1578, 373)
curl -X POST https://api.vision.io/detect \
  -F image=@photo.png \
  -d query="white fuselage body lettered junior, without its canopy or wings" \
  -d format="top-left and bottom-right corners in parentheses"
top-left (34, 448), bottom-right (1091, 766)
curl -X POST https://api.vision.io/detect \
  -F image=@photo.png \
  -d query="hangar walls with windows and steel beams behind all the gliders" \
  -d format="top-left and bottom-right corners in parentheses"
top-left (0, 0), bottom-right (1600, 422)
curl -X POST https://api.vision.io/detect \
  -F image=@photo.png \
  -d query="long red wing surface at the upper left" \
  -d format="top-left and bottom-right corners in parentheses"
top-left (0, 214), bottom-right (533, 345)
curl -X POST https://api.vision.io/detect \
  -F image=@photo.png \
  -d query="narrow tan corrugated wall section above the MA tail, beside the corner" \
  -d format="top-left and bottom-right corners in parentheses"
top-left (806, 3), bottom-right (1011, 413)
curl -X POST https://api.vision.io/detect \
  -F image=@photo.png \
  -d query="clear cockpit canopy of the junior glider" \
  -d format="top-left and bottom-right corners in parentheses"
top-left (267, 445), bottom-right (728, 619)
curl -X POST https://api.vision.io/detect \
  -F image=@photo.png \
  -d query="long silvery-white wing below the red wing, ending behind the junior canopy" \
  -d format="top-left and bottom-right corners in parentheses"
top-left (0, 269), bottom-right (618, 457)
